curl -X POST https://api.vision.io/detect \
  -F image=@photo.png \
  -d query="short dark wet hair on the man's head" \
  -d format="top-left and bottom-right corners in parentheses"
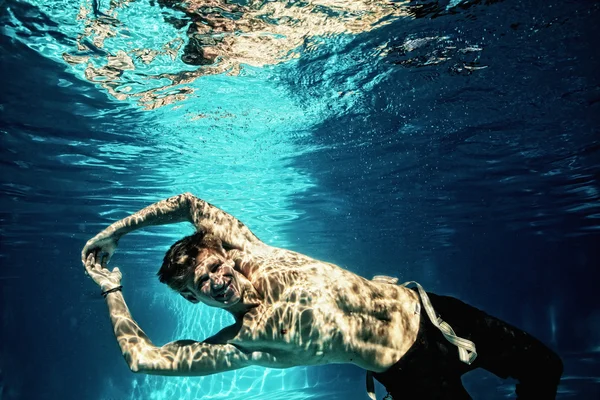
top-left (156, 230), bottom-right (223, 292)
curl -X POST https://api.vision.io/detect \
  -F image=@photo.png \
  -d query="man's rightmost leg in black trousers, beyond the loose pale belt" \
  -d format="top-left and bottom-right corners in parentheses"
top-left (428, 293), bottom-right (563, 400)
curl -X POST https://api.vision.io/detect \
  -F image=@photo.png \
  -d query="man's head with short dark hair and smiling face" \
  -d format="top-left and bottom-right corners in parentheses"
top-left (157, 231), bottom-right (243, 308)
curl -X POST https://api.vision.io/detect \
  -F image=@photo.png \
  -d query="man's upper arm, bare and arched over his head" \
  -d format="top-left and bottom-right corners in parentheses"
top-left (81, 193), bottom-right (262, 264)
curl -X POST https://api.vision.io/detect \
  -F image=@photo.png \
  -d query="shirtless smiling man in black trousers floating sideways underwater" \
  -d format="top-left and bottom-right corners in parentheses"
top-left (82, 193), bottom-right (562, 400)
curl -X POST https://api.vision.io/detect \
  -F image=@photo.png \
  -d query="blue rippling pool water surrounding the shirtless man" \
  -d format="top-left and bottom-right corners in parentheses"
top-left (0, 0), bottom-right (600, 400)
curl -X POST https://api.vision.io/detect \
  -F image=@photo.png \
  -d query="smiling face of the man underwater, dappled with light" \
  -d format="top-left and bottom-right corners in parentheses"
top-left (181, 249), bottom-right (241, 308)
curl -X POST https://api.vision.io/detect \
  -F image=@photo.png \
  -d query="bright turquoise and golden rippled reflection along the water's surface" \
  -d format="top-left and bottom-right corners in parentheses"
top-left (11, 0), bottom-right (424, 109)
